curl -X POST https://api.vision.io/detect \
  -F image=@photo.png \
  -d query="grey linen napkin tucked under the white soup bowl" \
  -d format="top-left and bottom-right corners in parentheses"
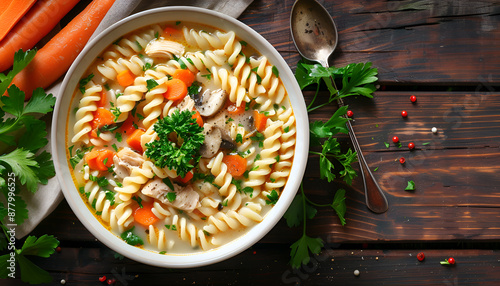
top-left (16, 0), bottom-right (253, 239)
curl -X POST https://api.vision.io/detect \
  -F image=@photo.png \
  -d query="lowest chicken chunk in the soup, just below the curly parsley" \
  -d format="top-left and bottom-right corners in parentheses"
top-left (141, 178), bottom-right (200, 212)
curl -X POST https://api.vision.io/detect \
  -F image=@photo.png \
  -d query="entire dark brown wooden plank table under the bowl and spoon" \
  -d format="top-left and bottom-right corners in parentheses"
top-left (29, 0), bottom-right (500, 285)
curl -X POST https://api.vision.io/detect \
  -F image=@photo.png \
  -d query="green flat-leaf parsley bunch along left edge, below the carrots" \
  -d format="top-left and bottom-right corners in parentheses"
top-left (0, 50), bottom-right (59, 284)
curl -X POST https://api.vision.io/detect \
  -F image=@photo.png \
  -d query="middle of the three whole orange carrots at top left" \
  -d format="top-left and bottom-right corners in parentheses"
top-left (0, 0), bottom-right (80, 72)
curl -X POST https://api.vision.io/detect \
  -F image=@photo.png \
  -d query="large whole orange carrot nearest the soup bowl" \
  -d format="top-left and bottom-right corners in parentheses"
top-left (7, 0), bottom-right (115, 99)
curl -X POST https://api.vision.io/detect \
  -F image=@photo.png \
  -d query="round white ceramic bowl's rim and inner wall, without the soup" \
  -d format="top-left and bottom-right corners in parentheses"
top-left (51, 6), bottom-right (309, 268)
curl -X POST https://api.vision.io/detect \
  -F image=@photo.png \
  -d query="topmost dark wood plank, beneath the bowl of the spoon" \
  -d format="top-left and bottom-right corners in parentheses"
top-left (240, 0), bottom-right (500, 85)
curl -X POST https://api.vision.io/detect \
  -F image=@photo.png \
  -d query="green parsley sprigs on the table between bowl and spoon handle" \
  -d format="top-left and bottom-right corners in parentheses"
top-left (284, 61), bottom-right (378, 268)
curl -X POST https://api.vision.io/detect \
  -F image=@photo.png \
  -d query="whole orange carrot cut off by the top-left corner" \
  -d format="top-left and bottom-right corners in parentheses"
top-left (0, 0), bottom-right (36, 40)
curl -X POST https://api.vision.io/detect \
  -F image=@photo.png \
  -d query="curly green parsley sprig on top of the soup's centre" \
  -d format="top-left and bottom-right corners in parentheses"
top-left (146, 109), bottom-right (205, 177)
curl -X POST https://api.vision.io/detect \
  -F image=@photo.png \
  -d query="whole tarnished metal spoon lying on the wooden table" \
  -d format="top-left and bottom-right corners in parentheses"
top-left (290, 0), bottom-right (389, 213)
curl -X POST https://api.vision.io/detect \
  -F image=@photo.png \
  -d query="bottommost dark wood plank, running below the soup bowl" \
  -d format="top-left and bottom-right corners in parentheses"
top-left (13, 244), bottom-right (500, 286)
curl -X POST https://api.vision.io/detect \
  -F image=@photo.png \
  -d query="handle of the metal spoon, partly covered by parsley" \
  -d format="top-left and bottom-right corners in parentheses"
top-left (338, 98), bottom-right (389, 213)
